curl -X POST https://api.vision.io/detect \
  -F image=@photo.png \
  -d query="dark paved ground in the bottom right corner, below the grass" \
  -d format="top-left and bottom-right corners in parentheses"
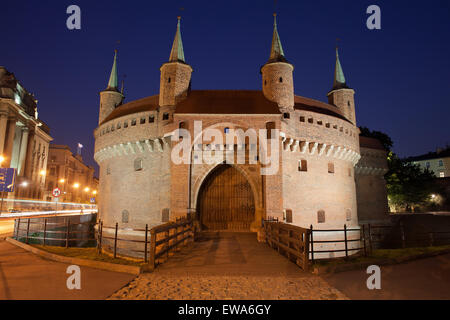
top-left (324, 254), bottom-right (450, 300)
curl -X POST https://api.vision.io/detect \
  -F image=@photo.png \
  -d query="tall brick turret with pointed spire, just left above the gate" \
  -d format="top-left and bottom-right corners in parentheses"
top-left (159, 17), bottom-right (192, 107)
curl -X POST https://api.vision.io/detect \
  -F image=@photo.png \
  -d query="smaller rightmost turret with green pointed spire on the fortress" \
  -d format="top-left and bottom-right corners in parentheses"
top-left (327, 48), bottom-right (356, 125)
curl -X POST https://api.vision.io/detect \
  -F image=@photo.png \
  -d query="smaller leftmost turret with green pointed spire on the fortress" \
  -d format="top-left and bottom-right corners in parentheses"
top-left (98, 50), bottom-right (124, 124)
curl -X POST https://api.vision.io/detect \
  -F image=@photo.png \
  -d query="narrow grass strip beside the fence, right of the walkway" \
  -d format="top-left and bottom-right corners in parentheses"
top-left (313, 245), bottom-right (450, 267)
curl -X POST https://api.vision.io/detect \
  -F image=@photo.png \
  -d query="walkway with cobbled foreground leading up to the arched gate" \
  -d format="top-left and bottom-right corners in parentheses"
top-left (110, 233), bottom-right (347, 300)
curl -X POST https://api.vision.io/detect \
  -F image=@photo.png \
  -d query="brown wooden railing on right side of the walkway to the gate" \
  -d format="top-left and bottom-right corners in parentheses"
top-left (263, 220), bottom-right (310, 271)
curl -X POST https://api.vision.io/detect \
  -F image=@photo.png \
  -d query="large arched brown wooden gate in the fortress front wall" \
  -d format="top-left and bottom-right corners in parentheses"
top-left (197, 164), bottom-right (255, 231)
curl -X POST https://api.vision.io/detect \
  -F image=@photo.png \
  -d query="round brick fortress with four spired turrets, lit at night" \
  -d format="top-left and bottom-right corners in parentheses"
top-left (94, 17), bottom-right (388, 257)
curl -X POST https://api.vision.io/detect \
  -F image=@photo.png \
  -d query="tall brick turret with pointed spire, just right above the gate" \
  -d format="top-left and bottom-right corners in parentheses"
top-left (261, 13), bottom-right (294, 113)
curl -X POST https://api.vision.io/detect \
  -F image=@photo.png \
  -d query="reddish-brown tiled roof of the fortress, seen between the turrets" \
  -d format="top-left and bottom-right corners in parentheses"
top-left (102, 90), bottom-right (352, 123)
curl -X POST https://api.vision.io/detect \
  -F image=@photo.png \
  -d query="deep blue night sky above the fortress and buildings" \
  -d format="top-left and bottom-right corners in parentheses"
top-left (0, 0), bottom-right (450, 175)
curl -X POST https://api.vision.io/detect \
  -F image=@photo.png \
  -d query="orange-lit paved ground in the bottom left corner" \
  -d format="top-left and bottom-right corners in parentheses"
top-left (0, 241), bottom-right (135, 300)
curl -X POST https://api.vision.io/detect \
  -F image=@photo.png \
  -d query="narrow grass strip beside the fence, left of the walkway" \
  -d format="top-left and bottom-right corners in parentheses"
top-left (32, 244), bottom-right (144, 267)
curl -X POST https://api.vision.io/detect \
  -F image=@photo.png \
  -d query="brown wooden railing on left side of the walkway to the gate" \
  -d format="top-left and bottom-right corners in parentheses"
top-left (97, 218), bottom-right (194, 269)
